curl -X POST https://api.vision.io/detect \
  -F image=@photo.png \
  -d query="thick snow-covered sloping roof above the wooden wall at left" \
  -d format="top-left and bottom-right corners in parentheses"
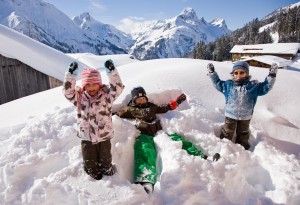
top-left (0, 25), bottom-right (86, 80)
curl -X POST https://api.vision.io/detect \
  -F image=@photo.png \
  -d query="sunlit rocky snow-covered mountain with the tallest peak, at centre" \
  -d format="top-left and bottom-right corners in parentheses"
top-left (130, 8), bottom-right (231, 60)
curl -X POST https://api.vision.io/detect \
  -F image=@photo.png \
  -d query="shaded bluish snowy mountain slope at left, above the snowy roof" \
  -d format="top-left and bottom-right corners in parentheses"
top-left (0, 0), bottom-right (132, 54)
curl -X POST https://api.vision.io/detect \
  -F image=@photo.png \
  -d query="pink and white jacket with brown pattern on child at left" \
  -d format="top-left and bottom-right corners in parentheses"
top-left (63, 69), bottom-right (124, 144)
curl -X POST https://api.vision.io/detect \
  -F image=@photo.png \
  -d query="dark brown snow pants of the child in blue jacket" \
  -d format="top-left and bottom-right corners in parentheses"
top-left (220, 117), bottom-right (250, 150)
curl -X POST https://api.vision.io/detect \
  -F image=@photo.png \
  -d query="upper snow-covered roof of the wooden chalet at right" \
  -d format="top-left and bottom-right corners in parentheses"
top-left (230, 43), bottom-right (300, 55)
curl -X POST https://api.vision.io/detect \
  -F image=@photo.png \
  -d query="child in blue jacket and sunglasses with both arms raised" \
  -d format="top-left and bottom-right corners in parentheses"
top-left (207, 61), bottom-right (278, 150)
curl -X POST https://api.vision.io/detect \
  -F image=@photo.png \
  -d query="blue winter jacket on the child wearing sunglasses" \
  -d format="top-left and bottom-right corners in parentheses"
top-left (209, 72), bottom-right (276, 120)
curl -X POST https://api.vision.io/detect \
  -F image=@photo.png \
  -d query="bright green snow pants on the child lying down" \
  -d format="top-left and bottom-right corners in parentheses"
top-left (134, 134), bottom-right (206, 184)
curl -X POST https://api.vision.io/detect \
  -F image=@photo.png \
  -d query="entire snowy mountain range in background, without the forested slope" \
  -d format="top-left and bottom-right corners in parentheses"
top-left (0, 0), bottom-right (230, 60)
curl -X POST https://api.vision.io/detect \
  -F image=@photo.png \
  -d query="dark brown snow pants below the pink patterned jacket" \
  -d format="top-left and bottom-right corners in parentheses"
top-left (81, 140), bottom-right (114, 180)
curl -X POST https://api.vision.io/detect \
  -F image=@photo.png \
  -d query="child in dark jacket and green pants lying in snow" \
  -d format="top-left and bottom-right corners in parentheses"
top-left (116, 87), bottom-right (220, 193)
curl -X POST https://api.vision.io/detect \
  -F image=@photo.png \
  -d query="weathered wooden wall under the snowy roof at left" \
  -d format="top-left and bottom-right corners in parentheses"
top-left (0, 55), bottom-right (62, 104)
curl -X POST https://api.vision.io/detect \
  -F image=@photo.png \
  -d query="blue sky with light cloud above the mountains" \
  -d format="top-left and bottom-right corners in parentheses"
top-left (44, 0), bottom-right (299, 30)
